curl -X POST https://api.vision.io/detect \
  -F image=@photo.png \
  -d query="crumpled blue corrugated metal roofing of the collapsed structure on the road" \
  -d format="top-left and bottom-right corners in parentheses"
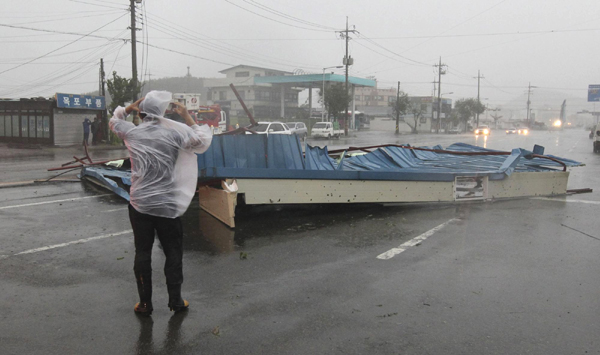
top-left (198, 135), bottom-right (582, 181)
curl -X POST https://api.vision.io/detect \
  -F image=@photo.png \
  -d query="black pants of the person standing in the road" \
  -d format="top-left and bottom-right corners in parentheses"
top-left (129, 205), bottom-right (183, 302)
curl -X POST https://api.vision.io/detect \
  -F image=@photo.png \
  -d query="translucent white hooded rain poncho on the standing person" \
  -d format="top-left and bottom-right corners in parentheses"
top-left (109, 91), bottom-right (212, 218)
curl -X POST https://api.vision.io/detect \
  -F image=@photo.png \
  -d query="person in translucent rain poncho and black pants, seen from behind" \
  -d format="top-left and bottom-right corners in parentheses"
top-left (109, 91), bottom-right (212, 315)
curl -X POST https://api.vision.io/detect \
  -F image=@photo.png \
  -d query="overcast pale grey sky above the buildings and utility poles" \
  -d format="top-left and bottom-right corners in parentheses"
top-left (0, 0), bottom-right (600, 113)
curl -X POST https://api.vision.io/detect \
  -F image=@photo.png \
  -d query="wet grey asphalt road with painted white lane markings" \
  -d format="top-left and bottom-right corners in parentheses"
top-left (0, 130), bottom-right (600, 354)
